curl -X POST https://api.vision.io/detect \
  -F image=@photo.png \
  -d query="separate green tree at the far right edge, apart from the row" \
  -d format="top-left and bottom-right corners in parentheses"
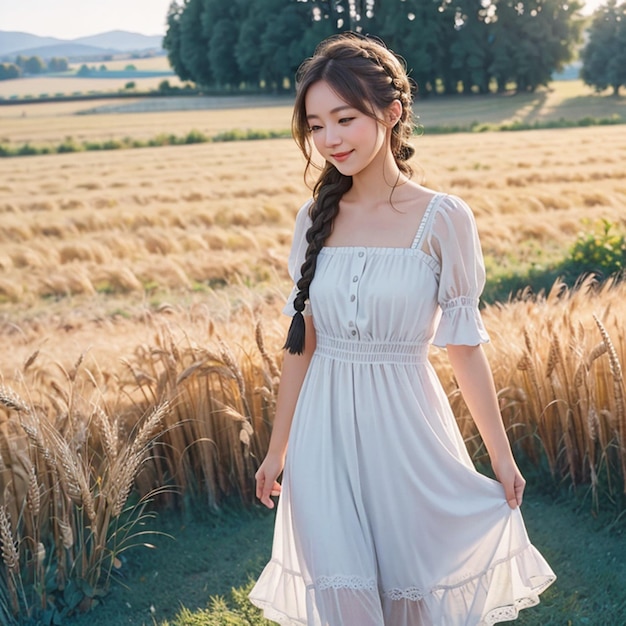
top-left (580, 0), bottom-right (626, 96)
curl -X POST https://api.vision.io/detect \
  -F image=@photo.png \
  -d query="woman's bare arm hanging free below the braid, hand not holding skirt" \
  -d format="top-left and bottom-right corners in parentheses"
top-left (255, 315), bottom-right (316, 509)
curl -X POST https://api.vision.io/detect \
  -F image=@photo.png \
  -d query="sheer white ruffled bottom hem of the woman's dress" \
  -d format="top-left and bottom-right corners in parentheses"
top-left (250, 545), bottom-right (556, 626)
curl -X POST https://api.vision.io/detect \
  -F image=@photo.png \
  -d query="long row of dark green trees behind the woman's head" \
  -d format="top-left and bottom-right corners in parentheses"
top-left (164, 0), bottom-right (583, 94)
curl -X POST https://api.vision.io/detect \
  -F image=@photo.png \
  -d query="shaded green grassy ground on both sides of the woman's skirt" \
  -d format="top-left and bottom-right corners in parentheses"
top-left (69, 487), bottom-right (626, 626)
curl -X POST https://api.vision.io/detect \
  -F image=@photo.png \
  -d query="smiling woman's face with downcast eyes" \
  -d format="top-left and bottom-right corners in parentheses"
top-left (304, 81), bottom-right (386, 176)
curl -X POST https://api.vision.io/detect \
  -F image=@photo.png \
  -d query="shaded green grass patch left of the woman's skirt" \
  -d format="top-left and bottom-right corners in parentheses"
top-left (67, 506), bottom-right (274, 626)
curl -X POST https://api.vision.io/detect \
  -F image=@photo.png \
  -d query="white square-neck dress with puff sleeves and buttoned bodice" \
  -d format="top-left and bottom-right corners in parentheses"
top-left (250, 194), bottom-right (555, 626)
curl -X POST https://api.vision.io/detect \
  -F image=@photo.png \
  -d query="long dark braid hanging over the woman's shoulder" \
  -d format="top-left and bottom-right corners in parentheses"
top-left (283, 165), bottom-right (352, 354)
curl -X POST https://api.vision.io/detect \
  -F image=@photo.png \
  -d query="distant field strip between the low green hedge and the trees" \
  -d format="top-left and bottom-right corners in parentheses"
top-left (0, 79), bottom-right (626, 145)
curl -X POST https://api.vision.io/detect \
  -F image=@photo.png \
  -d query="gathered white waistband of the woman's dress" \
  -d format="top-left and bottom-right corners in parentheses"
top-left (315, 333), bottom-right (428, 364)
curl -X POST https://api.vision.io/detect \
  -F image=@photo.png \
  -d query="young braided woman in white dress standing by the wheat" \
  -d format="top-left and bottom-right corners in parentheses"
top-left (250, 35), bottom-right (555, 626)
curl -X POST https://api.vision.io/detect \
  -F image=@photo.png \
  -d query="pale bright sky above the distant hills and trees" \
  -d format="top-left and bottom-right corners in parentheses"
top-left (0, 0), bottom-right (602, 39)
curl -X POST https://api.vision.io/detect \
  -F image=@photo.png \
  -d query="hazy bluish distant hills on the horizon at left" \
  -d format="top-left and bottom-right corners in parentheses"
top-left (0, 30), bottom-right (163, 61)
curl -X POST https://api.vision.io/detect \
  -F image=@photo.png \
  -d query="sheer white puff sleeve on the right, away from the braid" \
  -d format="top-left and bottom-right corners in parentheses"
top-left (428, 196), bottom-right (489, 348)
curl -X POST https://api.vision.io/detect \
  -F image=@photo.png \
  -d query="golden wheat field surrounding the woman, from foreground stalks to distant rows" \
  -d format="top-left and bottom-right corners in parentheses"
top-left (0, 97), bottom-right (626, 623)
